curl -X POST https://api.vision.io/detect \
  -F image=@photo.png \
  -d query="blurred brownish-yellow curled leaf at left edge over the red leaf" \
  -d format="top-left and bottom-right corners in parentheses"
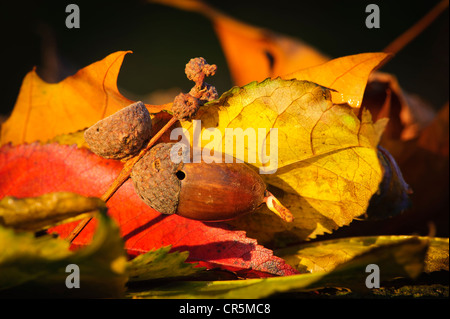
top-left (0, 192), bottom-right (106, 231)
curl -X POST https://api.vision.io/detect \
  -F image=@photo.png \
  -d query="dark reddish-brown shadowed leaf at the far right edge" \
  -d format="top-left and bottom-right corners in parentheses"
top-left (376, 104), bottom-right (449, 236)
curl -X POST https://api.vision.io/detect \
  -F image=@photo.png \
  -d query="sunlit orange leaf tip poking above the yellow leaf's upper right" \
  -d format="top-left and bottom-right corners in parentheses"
top-left (283, 52), bottom-right (390, 108)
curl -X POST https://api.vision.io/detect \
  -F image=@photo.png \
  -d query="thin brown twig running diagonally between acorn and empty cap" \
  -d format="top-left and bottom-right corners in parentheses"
top-left (66, 117), bottom-right (178, 242)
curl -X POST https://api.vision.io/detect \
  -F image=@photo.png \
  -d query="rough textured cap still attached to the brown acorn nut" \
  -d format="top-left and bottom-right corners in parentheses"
top-left (131, 143), bottom-right (183, 214)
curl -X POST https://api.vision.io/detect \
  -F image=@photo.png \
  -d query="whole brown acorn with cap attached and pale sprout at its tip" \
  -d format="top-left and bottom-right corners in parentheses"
top-left (131, 143), bottom-right (292, 221)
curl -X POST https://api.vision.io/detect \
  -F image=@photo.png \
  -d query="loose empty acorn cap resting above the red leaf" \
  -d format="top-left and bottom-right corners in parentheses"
top-left (84, 102), bottom-right (152, 159)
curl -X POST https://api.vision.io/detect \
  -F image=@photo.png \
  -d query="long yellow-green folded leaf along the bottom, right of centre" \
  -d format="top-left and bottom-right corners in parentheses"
top-left (127, 238), bottom-right (428, 299)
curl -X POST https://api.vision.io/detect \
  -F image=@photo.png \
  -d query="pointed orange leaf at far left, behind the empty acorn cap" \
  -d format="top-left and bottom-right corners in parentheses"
top-left (0, 51), bottom-right (165, 144)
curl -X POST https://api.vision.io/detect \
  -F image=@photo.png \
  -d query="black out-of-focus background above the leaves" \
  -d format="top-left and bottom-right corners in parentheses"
top-left (0, 0), bottom-right (449, 115)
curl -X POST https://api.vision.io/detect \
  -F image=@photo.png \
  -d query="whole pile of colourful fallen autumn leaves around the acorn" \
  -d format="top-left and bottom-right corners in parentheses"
top-left (0, 1), bottom-right (449, 298)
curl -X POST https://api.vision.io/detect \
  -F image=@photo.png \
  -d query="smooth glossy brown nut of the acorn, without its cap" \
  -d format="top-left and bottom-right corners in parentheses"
top-left (177, 162), bottom-right (266, 221)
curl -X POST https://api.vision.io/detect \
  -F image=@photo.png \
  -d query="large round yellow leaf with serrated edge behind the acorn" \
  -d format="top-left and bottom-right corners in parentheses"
top-left (178, 79), bottom-right (386, 244)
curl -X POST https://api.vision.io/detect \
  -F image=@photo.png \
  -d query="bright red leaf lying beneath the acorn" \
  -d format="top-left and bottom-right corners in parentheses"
top-left (0, 143), bottom-right (296, 276)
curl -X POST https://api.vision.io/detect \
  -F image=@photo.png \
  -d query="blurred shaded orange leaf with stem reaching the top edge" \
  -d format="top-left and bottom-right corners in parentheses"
top-left (154, 0), bottom-right (328, 86)
